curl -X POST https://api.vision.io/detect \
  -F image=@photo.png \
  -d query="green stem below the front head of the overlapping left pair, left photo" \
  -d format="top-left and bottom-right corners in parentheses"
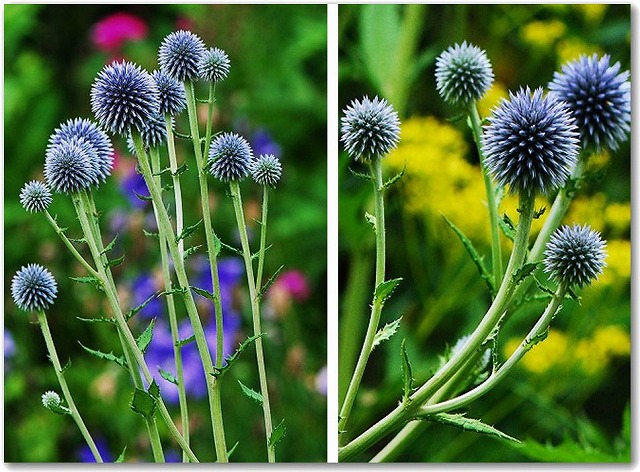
top-left (72, 192), bottom-right (199, 462)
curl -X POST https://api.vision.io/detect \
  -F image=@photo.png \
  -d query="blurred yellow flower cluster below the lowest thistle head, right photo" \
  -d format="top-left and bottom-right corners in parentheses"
top-left (504, 325), bottom-right (631, 375)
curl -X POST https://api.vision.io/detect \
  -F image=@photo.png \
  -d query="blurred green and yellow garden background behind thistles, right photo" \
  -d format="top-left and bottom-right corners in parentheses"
top-left (339, 4), bottom-right (631, 462)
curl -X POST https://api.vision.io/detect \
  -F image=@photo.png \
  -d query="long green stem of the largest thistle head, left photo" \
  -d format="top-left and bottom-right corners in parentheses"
top-left (132, 133), bottom-right (228, 462)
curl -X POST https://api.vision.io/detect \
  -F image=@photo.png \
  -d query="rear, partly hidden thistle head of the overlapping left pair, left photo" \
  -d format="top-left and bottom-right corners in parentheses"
top-left (47, 118), bottom-right (113, 185)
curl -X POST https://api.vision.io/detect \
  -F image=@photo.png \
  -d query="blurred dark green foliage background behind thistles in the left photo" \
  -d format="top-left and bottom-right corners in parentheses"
top-left (4, 4), bottom-right (327, 462)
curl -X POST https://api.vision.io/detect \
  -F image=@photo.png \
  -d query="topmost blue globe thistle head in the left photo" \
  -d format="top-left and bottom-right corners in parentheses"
top-left (158, 30), bottom-right (205, 82)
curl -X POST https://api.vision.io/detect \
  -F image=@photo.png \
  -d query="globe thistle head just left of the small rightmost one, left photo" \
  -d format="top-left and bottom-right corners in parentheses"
top-left (209, 133), bottom-right (253, 182)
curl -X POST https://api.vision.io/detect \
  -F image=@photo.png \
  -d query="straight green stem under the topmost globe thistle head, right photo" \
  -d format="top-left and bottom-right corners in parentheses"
top-left (468, 102), bottom-right (502, 286)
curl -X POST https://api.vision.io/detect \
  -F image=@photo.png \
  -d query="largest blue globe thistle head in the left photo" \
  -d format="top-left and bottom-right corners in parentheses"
top-left (91, 61), bottom-right (160, 135)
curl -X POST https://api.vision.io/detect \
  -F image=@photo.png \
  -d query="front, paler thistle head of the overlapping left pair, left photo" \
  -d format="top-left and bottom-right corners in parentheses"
top-left (44, 137), bottom-right (99, 193)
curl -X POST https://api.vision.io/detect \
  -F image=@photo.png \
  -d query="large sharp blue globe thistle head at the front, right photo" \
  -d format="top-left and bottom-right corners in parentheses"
top-left (483, 87), bottom-right (579, 195)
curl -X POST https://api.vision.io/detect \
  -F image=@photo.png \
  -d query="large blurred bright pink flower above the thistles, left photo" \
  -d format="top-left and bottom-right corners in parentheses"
top-left (91, 12), bottom-right (147, 52)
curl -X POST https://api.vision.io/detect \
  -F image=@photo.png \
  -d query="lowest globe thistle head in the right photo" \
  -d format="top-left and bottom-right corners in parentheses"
top-left (544, 224), bottom-right (606, 288)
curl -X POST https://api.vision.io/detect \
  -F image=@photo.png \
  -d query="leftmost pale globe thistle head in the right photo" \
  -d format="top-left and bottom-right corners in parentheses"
top-left (340, 96), bottom-right (400, 161)
